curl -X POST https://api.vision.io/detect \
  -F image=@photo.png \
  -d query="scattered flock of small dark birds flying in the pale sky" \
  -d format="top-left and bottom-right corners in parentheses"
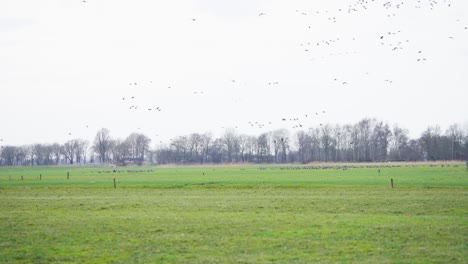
top-left (62, 0), bottom-right (468, 144)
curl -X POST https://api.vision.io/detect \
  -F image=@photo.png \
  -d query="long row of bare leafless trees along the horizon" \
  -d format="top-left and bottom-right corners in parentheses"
top-left (0, 118), bottom-right (468, 166)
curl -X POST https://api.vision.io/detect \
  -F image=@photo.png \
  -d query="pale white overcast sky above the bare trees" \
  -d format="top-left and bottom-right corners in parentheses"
top-left (0, 0), bottom-right (468, 145)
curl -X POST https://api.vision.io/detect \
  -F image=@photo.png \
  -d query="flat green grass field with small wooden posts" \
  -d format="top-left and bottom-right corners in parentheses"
top-left (0, 164), bottom-right (468, 263)
